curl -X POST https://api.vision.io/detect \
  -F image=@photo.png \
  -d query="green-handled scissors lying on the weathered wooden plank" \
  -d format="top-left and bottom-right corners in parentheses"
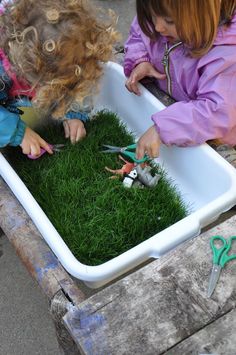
top-left (207, 235), bottom-right (236, 297)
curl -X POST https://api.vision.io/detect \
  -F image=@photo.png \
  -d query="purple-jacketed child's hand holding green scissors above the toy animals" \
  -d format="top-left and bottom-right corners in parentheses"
top-left (136, 126), bottom-right (161, 159)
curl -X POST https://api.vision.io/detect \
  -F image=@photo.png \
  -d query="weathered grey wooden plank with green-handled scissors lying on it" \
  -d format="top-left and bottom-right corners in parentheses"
top-left (64, 216), bottom-right (236, 355)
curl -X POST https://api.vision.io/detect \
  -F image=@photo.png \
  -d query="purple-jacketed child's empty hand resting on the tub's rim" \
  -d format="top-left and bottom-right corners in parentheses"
top-left (125, 62), bottom-right (166, 95)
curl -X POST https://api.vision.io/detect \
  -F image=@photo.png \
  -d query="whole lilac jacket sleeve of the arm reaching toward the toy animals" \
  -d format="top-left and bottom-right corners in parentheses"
top-left (152, 57), bottom-right (236, 146)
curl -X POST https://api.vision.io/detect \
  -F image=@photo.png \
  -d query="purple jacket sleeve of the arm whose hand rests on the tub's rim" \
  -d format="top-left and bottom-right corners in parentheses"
top-left (124, 17), bottom-right (150, 77)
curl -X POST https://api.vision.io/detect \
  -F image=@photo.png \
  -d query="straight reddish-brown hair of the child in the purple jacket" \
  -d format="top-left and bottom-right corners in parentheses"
top-left (136, 0), bottom-right (236, 56)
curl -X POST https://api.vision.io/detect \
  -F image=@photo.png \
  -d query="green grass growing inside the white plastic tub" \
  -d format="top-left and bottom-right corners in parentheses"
top-left (8, 111), bottom-right (187, 265)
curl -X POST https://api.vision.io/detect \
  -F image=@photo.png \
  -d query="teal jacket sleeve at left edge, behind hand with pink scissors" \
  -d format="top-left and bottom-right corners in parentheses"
top-left (0, 106), bottom-right (26, 148)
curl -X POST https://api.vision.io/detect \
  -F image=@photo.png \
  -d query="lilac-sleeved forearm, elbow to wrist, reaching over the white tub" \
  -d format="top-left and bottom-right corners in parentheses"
top-left (152, 99), bottom-right (233, 146)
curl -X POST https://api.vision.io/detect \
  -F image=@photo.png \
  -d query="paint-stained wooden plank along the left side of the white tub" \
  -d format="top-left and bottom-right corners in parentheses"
top-left (0, 178), bottom-right (85, 304)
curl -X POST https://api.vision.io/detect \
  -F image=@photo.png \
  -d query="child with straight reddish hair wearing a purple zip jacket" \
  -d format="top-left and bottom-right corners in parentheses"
top-left (124, 0), bottom-right (236, 165)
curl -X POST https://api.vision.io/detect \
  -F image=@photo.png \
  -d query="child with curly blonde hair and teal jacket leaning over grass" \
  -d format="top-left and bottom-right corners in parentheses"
top-left (0, 0), bottom-right (118, 156)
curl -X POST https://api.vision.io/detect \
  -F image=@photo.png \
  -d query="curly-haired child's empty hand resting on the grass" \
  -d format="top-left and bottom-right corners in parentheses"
top-left (63, 118), bottom-right (86, 144)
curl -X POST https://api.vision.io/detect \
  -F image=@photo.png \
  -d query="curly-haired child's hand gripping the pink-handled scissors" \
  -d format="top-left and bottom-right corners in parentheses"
top-left (20, 127), bottom-right (53, 156)
